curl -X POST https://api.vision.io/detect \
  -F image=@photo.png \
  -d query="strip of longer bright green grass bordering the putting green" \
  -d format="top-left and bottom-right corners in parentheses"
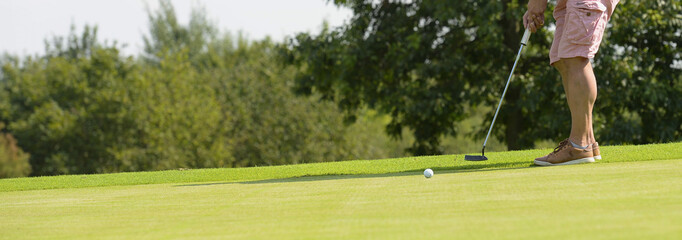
top-left (0, 142), bottom-right (682, 192)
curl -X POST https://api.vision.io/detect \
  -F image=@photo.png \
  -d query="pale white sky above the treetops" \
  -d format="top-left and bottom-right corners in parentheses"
top-left (0, 0), bottom-right (352, 56)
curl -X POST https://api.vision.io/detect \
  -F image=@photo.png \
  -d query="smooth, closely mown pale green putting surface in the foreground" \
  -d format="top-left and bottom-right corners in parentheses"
top-left (0, 160), bottom-right (682, 239)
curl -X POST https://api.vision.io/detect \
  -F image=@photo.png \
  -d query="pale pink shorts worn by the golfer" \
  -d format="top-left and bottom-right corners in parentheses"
top-left (549, 0), bottom-right (619, 64)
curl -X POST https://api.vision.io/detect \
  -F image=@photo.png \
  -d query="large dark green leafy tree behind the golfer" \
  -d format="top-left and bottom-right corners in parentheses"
top-left (283, 0), bottom-right (682, 154)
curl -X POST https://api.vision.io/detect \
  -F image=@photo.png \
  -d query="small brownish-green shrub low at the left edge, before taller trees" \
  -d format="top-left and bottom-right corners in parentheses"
top-left (0, 122), bottom-right (31, 178)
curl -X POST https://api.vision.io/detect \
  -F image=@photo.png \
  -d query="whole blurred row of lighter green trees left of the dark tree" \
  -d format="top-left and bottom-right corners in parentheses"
top-left (0, 1), bottom-right (398, 175)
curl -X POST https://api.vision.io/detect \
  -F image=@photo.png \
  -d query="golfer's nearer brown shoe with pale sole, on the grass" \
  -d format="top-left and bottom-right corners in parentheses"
top-left (534, 139), bottom-right (599, 166)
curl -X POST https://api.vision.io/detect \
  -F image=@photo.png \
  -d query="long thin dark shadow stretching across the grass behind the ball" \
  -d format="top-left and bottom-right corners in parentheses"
top-left (174, 163), bottom-right (536, 187)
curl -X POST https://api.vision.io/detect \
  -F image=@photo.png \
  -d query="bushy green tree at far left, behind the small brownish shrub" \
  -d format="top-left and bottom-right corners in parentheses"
top-left (2, 27), bottom-right (141, 175)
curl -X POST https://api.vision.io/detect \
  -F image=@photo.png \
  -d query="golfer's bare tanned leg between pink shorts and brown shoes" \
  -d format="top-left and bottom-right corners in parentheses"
top-left (554, 57), bottom-right (597, 146)
